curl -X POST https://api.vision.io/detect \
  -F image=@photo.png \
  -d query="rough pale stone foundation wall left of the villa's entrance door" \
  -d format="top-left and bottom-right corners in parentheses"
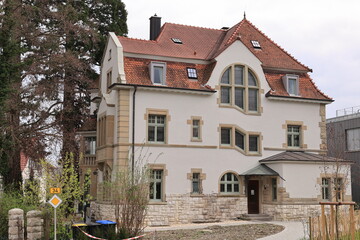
top-left (91, 194), bottom-right (247, 226)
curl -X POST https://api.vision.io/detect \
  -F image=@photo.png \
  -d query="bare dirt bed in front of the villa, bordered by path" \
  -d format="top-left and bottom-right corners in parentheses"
top-left (143, 223), bottom-right (284, 240)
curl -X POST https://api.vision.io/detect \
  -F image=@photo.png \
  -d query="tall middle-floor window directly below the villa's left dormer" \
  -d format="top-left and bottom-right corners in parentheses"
top-left (148, 114), bottom-right (166, 143)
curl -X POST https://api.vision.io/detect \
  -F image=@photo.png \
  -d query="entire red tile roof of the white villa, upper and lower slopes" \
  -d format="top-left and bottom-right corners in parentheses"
top-left (118, 18), bottom-right (331, 100)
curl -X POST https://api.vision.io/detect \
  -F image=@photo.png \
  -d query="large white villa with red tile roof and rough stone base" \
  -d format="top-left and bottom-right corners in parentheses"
top-left (92, 16), bottom-right (351, 225)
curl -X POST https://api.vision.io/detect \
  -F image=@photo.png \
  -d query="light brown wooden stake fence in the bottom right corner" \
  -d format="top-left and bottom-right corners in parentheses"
top-left (309, 202), bottom-right (360, 240)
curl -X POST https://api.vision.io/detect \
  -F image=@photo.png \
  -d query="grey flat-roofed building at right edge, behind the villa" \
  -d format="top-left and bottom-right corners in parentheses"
top-left (326, 106), bottom-right (360, 203)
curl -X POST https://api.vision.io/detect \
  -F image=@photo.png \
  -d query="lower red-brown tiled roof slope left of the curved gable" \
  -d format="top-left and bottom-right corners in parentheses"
top-left (124, 57), bottom-right (215, 91)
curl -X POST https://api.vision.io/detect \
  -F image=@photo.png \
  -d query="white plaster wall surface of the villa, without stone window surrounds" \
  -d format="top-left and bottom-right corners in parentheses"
top-left (102, 38), bottom-right (330, 197)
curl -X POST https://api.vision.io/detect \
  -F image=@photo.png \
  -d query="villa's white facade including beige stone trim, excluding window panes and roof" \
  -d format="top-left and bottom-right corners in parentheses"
top-left (92, 26), bottom-right (351, 223)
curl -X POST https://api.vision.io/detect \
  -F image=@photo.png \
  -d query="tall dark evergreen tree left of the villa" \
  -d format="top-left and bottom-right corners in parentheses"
top-left (0, 0), bottom-right (127, 188)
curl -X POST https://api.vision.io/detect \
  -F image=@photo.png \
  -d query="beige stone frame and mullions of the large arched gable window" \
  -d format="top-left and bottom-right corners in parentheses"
top-left (218, 63), bottom-right (262, 114)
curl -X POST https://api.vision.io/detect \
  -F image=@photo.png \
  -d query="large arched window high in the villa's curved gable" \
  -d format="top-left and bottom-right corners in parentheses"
top-left (220, 65), bottom-right (259, 113)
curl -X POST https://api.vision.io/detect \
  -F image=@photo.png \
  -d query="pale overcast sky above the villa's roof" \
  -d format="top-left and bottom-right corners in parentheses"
top-left (123, 0), bottom-right (360, 118)
